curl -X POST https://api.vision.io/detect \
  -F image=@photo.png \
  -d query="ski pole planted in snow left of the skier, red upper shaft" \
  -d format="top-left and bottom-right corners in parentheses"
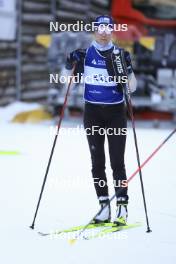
top-left (30, 65), bottom-right (75, 229)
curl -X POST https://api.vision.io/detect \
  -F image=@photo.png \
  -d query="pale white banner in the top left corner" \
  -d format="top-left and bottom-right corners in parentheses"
top-left (0, 0), bottom-right (16, 40)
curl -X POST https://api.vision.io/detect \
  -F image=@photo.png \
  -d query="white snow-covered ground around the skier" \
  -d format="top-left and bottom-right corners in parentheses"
top-left (0, 118), bottom-right (176, 264)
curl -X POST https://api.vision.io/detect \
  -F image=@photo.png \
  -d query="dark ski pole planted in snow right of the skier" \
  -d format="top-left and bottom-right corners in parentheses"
top-left (121, 50), bottom-right (152, 233)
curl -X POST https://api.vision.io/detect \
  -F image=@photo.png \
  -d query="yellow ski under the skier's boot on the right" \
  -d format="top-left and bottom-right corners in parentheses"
top-left (84, 223), bottom-right (142, 240)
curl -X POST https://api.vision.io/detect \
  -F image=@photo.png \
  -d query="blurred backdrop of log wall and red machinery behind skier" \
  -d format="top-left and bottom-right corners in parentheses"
top-left (0, 0), bottom-right (176, 125)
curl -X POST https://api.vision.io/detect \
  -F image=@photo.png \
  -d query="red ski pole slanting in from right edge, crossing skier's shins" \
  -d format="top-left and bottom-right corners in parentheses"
top-left (71, 128), bottom-right (176, 243)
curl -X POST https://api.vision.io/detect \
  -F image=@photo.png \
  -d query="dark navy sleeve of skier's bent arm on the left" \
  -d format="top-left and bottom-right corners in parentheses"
top-left (66, 49), bottom-right (86, 70)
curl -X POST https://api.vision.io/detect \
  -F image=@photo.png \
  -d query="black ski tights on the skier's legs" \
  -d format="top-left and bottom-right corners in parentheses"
top-left (84, 103), bottom-right (128, 198)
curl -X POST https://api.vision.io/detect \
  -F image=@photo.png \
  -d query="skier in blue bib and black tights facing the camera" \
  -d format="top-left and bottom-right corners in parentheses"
top-left (66, 15), bottom-right (136, 225)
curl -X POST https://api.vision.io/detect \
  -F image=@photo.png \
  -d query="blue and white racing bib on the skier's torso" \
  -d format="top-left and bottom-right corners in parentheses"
top-left (84, 46), bottom-right (124, 104)
